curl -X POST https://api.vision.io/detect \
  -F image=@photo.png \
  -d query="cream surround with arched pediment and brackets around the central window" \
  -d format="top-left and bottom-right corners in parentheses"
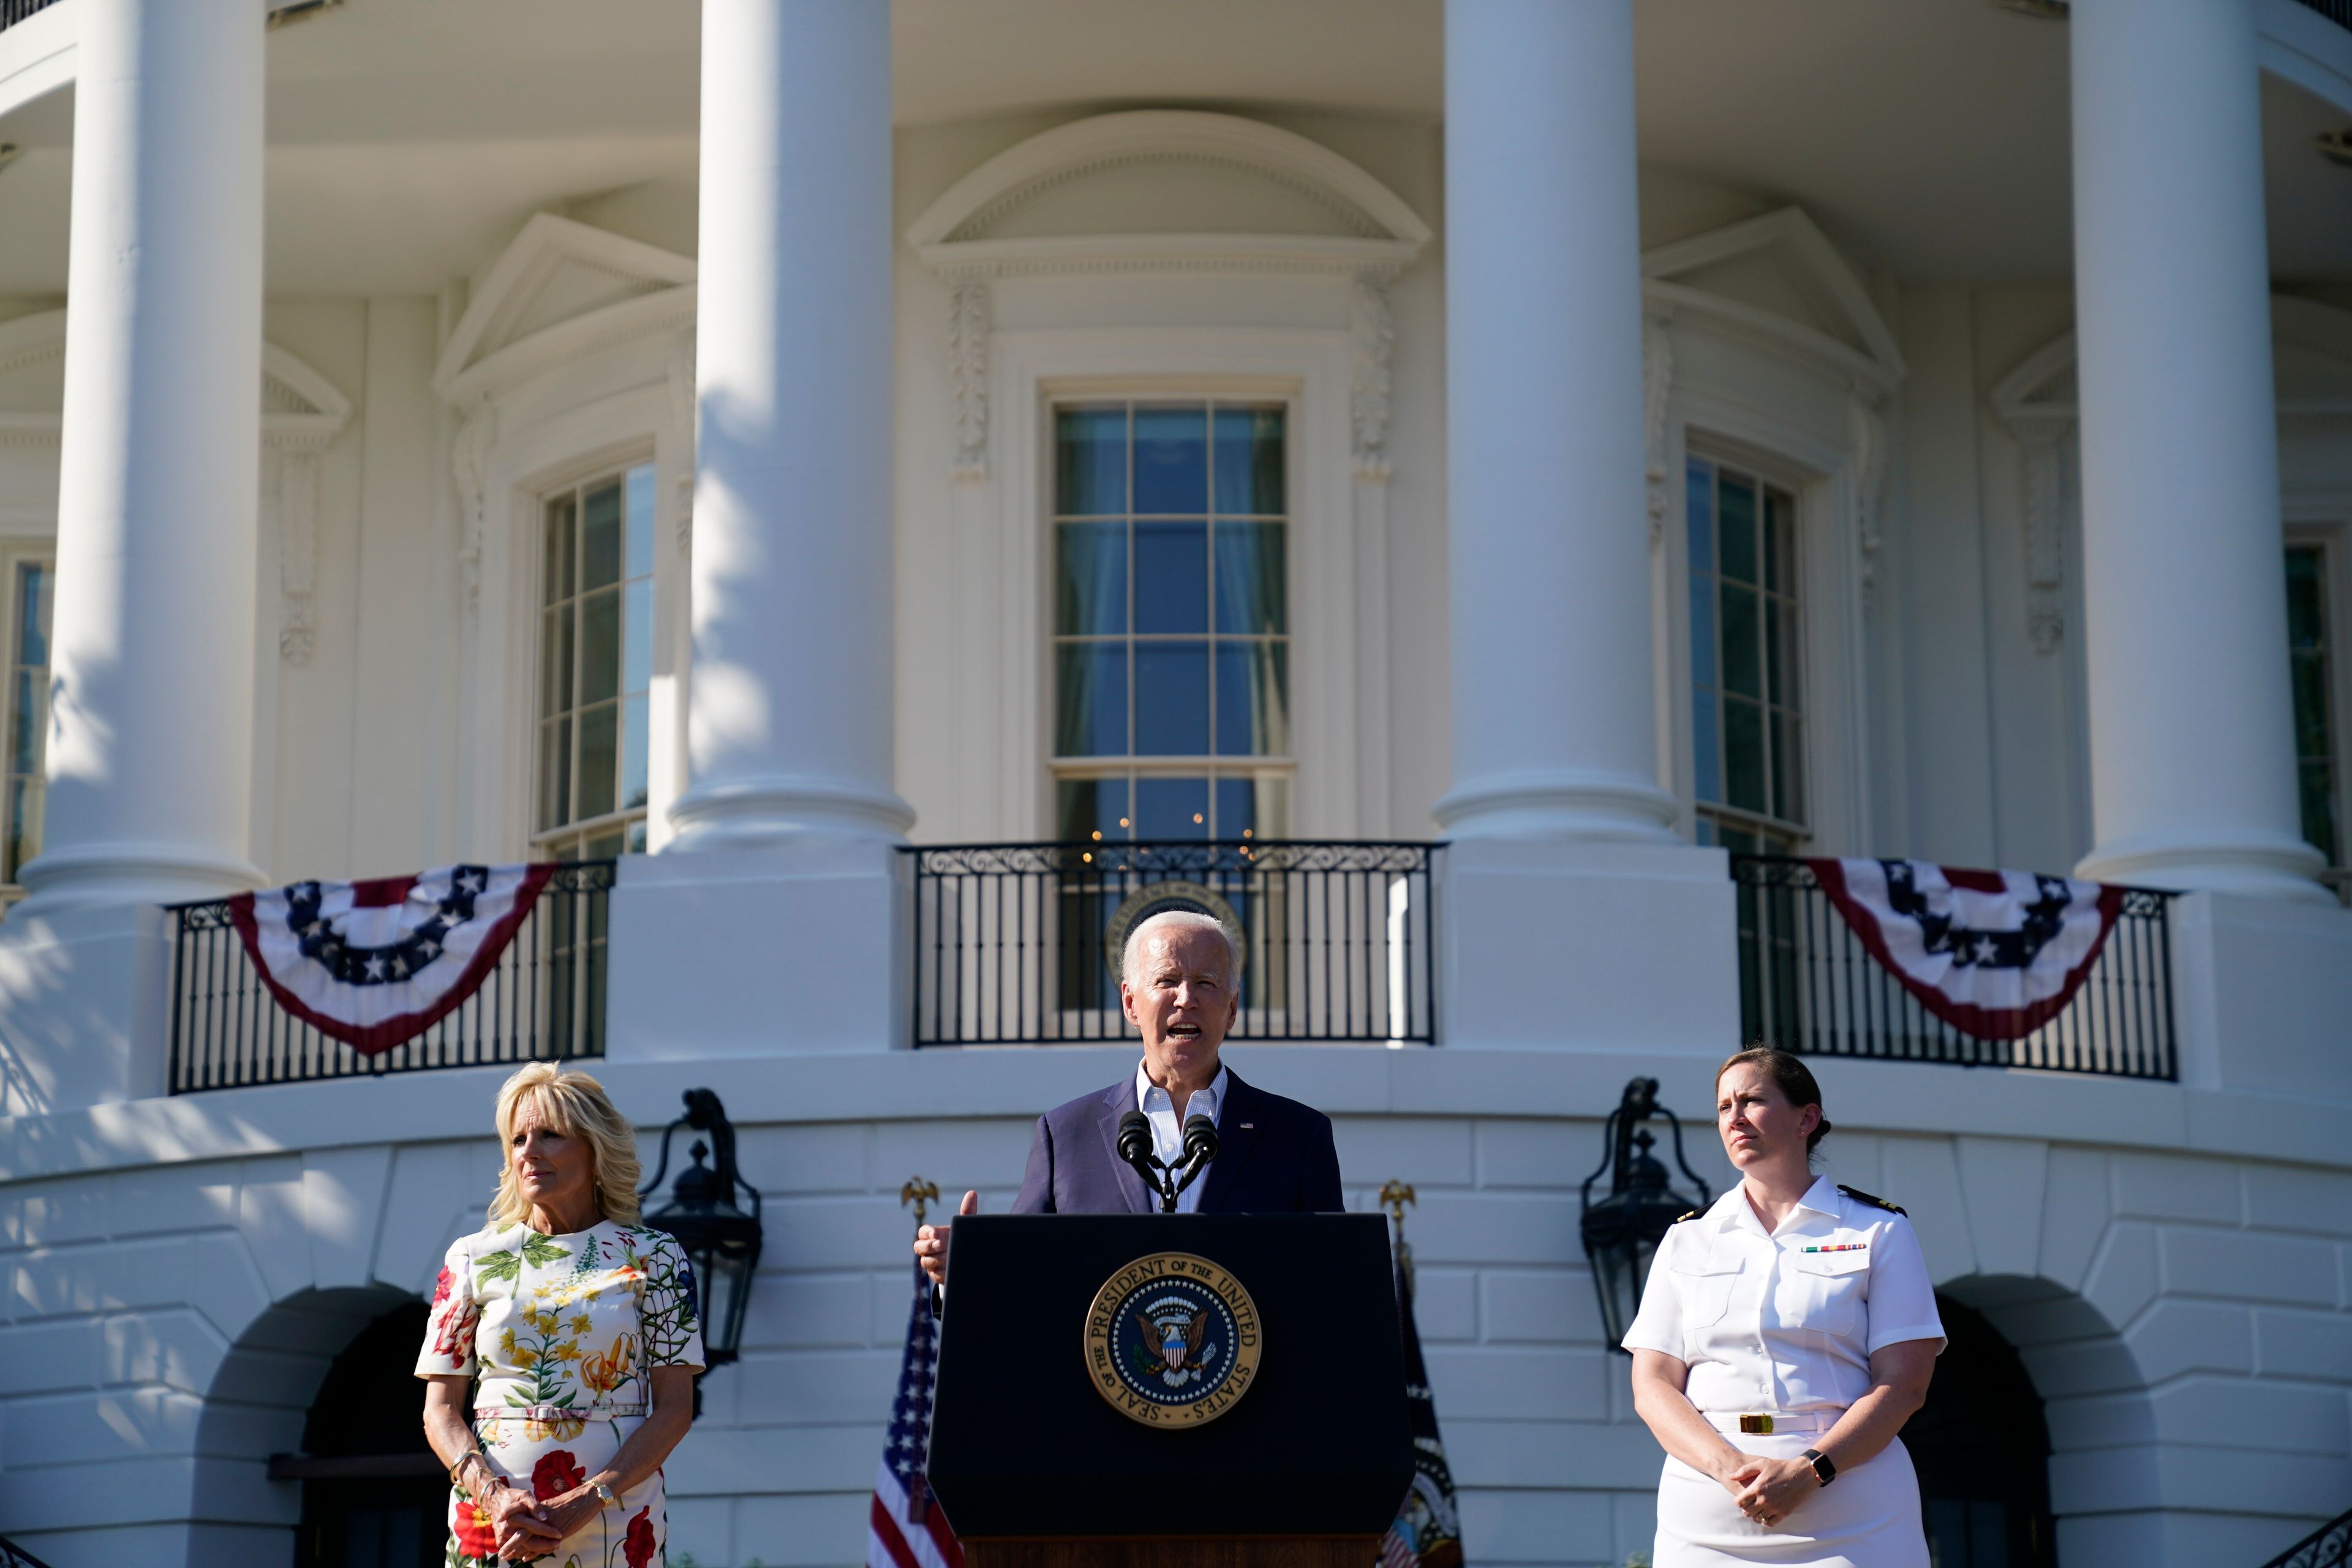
top-left (905, 110), bottom-right (1430, 837)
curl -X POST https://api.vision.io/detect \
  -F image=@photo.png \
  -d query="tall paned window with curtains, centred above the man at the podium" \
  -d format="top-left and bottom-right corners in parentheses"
top-left (1051, 402), bottom-right (1291, 842)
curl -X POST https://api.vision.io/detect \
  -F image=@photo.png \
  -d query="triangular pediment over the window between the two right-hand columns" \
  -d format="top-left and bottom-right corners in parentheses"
top-left (1642, 207), bottom-right (1903, 393)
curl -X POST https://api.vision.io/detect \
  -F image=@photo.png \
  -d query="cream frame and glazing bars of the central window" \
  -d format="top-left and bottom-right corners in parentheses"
top-left (1037, 385), bottom-right (1301, 837)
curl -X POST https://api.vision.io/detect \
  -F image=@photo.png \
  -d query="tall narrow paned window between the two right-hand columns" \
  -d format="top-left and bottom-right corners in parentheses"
top-left (1689, 458), bottom-right (1806, 853)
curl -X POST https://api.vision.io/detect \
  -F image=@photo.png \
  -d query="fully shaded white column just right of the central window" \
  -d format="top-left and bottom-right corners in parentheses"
top-left (1437, 0), bottom-right (1675, 842)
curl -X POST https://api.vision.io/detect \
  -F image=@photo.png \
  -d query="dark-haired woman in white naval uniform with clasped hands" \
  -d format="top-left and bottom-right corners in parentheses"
top-left (1625, 1049), bottom-right (1943, 1568)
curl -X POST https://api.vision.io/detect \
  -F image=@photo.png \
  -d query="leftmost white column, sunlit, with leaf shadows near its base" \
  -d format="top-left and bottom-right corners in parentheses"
top-left (23, 0), bottom-right (263, 912)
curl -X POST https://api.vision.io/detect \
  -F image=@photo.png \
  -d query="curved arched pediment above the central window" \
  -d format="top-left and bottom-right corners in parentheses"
top-left (905, 108), bottom-right (1430, 275)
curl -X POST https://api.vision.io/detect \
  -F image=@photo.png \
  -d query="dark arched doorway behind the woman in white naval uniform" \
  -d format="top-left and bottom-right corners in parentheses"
top-left (1903, 1295), bottom-right (2058, 1568)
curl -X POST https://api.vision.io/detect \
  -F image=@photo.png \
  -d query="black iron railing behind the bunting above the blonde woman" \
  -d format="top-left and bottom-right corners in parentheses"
top-left (169, 861), bottom-right (614, 1093)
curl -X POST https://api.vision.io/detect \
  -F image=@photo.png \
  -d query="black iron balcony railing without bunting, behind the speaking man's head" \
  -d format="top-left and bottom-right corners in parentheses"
top-left (905, 839), bottom-right (1439, 1046)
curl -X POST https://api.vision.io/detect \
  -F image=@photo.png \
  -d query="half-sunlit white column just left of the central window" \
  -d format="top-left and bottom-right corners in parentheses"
top-left (670, 0), bottom-right (913, 851)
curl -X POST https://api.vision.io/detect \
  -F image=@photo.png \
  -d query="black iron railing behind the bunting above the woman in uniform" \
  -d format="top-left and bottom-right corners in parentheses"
top-left (1731, 856), bottom-right (2178, 1079)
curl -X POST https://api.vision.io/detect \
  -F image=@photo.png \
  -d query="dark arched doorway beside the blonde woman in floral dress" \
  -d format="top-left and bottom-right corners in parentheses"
top-left (289, 1302), bottom-right (449, 1568)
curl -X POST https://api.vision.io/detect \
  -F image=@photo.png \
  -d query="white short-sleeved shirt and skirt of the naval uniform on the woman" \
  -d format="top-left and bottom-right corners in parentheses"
top-left (1625, 1178), bottom-right (1945, 1568)
